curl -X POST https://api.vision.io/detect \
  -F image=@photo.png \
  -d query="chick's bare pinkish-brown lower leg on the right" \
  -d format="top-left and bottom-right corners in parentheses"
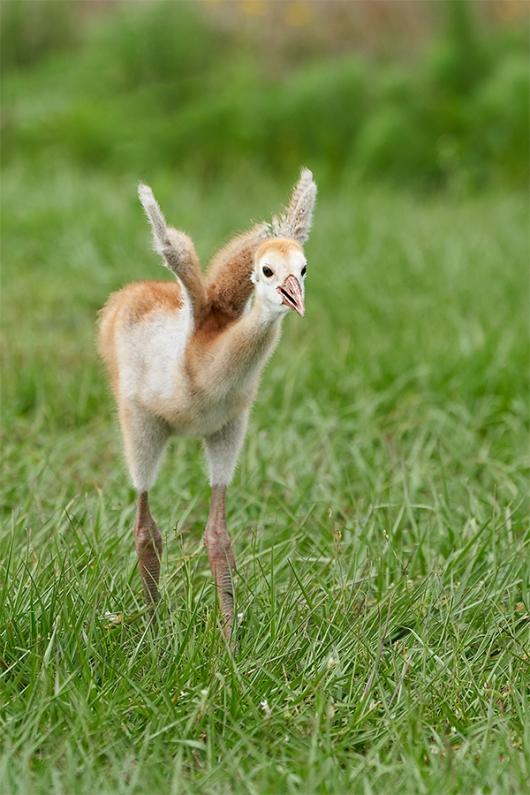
top-left (204, 485), bottom-right (236, 640)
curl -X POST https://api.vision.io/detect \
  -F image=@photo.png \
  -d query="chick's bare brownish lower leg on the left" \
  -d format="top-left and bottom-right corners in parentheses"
top-left (134, 491), bottom-right (162, 612)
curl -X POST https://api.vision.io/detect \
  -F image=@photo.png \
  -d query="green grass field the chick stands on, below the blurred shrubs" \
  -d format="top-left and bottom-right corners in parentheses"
top-left (0, 163), bottom-right (530, 795)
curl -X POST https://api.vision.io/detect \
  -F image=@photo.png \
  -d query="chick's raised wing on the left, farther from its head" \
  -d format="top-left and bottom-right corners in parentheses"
top-left (138, 183), bottom-right (207, 318)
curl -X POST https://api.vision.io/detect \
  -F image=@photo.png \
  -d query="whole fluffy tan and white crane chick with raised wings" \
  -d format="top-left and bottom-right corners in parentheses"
top-left (99, 171), bottom-right (316, 634)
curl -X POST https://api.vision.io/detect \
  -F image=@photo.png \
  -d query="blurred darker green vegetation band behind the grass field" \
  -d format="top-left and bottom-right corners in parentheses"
top-left (1, 0), bottom-right (530, 192)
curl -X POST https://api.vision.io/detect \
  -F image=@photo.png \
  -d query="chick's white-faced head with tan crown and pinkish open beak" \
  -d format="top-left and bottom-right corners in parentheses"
top-left (252, 238), bottom-right (306, 317)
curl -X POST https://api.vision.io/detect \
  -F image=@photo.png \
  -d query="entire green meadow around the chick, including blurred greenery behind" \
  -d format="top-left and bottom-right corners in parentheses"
top-left (0, 0), bottom-right (530, 795)
